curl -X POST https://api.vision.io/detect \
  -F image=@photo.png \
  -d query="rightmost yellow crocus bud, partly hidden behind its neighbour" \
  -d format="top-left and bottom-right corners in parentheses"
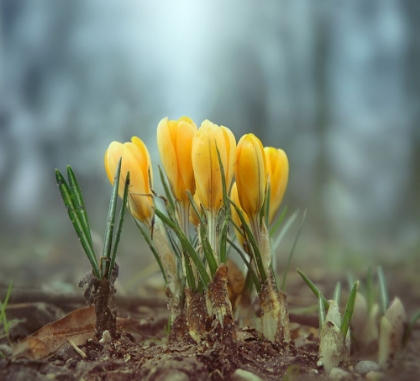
top-left (264, 147), bottom-right (289, 223)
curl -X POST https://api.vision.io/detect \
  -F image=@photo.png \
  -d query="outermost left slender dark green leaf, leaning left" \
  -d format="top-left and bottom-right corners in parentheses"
top-left (55, 169), bottom-right (101, 279)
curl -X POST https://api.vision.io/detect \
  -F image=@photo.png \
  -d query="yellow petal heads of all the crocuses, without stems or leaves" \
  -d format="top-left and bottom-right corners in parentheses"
top-left (105, 117), bottom-right (289, 235)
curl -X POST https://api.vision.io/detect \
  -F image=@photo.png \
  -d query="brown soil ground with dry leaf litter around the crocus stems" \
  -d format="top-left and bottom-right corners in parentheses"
top-left (0, 254), bottom-right (420, 381)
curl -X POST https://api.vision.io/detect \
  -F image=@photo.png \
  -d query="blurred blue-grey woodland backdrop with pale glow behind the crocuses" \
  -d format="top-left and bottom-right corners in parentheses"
top-left (0, 0), bottom-right (420, 289)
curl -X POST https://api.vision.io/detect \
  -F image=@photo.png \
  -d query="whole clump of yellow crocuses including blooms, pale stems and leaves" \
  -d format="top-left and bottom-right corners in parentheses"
top-left (105, 117), bottom-right (289, 341)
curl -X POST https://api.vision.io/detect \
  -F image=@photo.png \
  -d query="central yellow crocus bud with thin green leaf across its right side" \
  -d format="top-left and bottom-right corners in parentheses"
top-left (192, 120), bottom-right (236, 212)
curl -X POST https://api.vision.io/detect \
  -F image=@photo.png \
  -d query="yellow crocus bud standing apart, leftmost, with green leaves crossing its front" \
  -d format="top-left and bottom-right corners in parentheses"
top-left (105, 137), bottom-right (153, 226)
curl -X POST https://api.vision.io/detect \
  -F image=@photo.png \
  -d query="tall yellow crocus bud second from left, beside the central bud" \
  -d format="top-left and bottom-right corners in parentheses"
top-left (157, 116), bottom-right (197, 202)
